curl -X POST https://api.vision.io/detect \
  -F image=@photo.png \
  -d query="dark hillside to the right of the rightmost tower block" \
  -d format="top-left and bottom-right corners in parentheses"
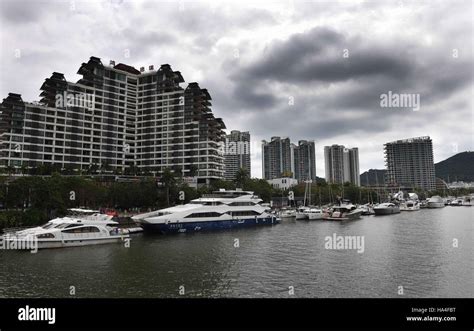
top-left (435, 152), bottom-right (474, 182)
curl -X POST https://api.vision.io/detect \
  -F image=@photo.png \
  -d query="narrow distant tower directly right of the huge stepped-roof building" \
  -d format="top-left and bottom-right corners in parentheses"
top-left (224, 130), bottom-right (251, 180)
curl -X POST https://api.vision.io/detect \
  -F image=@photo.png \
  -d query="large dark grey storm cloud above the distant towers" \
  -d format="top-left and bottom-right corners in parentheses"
top-left (229, 21), bottom-right (472, 138)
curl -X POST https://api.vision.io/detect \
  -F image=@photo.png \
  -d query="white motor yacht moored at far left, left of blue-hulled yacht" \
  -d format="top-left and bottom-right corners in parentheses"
top-left (1, 210), bottom-right (129, 249)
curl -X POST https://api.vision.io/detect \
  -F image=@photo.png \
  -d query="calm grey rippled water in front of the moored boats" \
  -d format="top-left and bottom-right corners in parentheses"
top-left (0, 207), bottom-right (474, 297)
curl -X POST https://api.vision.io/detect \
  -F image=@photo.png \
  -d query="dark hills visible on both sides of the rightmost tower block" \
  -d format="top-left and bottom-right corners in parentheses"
top-left (360, 152), bottom-right (474, 185)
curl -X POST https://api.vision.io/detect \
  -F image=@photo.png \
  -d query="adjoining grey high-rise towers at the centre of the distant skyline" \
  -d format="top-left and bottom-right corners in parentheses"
top-left (262, 137), bottom-right (316, 182)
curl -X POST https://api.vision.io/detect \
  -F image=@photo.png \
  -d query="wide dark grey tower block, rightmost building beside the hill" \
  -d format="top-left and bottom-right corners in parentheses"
top-left (384, 136), bottom-right (436, 190)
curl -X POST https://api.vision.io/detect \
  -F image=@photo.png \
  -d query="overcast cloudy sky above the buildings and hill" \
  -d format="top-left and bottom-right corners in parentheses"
top-left (0, 0), bottom-right (474, 177)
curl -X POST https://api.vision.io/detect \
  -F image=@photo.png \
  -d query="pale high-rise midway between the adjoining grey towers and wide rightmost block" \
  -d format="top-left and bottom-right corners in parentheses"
top-left (324, 145), bottom-right (360, 186)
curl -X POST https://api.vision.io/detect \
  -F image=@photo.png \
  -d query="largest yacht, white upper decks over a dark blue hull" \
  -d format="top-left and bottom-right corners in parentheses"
top-left (132, 189), bottom-right (278, 234)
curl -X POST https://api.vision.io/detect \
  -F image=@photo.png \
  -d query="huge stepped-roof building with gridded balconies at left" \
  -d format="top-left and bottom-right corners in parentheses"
top-left (0, 57), bottom-right (225, 181)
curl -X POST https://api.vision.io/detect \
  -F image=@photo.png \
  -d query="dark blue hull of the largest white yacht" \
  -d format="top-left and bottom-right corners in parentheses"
top-left (142, 217), bottom-right (279, 234)
